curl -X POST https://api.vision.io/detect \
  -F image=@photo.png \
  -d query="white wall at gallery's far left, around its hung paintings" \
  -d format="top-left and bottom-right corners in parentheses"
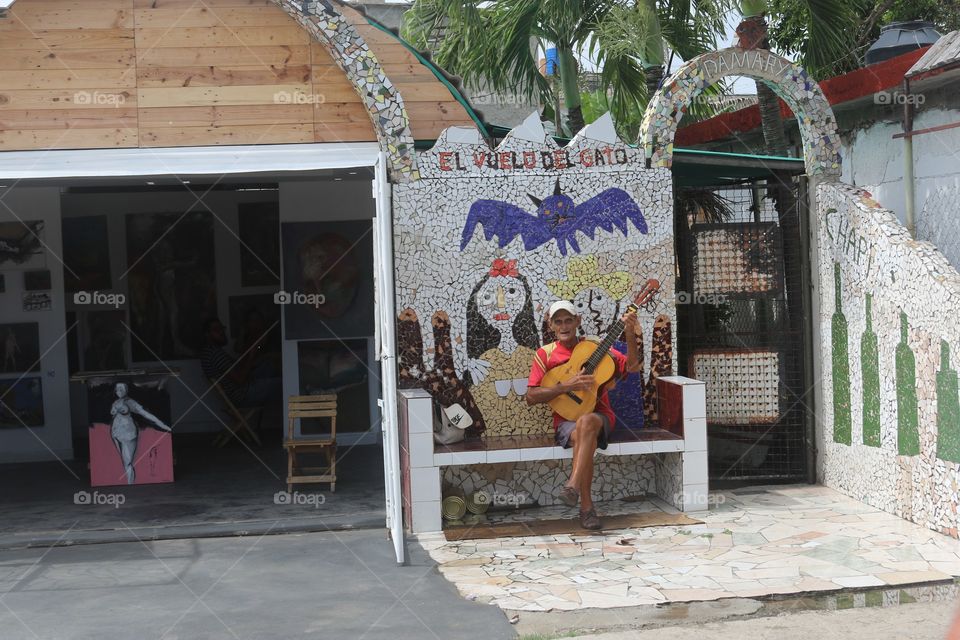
top-left (0, 187), bottom-right (73, 462)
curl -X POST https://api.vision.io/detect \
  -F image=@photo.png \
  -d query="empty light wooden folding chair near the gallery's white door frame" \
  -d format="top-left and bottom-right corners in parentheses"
top-left (283, 393), bottom-right (337, 493)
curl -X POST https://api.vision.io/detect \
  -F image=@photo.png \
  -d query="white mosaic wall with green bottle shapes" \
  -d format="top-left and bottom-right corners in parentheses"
top-left (818, 183), bottom-right (960, 537)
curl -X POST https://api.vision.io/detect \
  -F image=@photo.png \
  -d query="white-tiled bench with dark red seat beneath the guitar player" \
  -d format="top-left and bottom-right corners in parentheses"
top-left (399, 376), bottom-right (709, 533)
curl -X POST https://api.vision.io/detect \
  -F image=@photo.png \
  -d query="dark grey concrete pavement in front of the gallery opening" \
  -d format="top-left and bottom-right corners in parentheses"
top-left (0, 530), bottom-right (515, 640)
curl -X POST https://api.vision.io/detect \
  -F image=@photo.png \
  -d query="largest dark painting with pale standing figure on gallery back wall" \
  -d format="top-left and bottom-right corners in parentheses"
top-left (126, 212), bottom-right (217, 362)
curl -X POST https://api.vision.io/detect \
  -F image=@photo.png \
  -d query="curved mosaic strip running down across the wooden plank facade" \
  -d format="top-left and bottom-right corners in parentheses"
top-left (273, 0), bottom-right (419, 182)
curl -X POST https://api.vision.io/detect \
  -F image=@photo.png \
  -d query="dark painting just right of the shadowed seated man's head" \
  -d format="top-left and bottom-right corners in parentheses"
top-left (229, 293), bottom-right (282, 376)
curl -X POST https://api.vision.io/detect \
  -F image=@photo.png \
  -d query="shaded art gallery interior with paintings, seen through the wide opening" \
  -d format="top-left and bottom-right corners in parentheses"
top-left (0, 166), bottom-right (392, 538)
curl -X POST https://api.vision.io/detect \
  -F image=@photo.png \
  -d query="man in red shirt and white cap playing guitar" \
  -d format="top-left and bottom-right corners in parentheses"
top-left (527, 300), bottom-right (640, 529)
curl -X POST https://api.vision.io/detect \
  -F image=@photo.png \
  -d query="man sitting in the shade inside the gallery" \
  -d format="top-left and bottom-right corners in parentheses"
top-left (200, 318), bottom-right (283, 407)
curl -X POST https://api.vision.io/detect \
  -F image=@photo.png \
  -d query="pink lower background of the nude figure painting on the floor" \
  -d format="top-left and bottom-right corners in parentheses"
top-left (89, 423), bottom-right (173, 487)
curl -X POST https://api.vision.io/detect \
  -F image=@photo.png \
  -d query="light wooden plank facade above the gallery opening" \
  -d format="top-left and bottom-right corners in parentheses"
top-left (0, 0), bottom-right (471, 151)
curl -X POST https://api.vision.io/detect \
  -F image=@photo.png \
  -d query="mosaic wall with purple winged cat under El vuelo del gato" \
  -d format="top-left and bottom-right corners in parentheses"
top-left (393, 114), bottom-right (676, 436)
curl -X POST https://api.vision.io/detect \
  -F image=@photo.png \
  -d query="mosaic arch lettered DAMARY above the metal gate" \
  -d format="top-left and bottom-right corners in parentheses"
top-left (641, 47), bottom-right (840, 178)
